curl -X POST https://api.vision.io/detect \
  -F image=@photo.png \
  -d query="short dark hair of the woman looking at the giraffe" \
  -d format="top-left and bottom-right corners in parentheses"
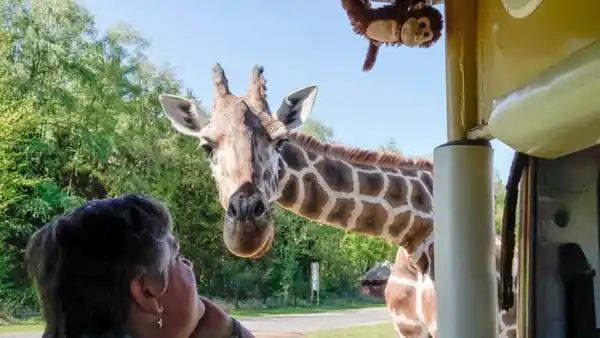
top-left (26, 195), bottom-right (172, 338)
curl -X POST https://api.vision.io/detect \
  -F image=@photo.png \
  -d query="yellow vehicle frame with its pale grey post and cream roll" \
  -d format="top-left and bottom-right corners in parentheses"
top-left (434, 0), bottom-right (600, 338)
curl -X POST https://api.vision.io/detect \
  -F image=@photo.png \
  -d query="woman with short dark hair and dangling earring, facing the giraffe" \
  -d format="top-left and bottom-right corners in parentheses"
top-left (26, 195), bottom-right (254, 338)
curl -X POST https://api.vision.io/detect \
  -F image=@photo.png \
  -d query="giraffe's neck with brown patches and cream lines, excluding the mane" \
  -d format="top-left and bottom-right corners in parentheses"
top-left (277, 140), bottom-right (433, 252)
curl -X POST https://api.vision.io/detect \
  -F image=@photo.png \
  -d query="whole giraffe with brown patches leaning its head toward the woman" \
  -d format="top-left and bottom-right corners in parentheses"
top-left (159, 63), bottom-right (516, 338)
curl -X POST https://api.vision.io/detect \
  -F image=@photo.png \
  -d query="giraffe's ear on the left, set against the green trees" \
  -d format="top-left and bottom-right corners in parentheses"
top-left (158, 94), bottom-right (208, 136)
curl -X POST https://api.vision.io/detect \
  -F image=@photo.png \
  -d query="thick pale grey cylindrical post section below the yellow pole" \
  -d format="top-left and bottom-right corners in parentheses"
top-left (433, 140), bottom-right (498, 338)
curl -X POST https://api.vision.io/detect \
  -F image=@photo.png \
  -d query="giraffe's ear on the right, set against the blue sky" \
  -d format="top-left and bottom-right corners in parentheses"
top-left (275, 86), bottom-right (319, 130)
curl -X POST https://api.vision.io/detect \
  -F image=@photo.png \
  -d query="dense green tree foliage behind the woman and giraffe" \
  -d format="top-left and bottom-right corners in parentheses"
top-left (0, 0), bottom-right (508, 315)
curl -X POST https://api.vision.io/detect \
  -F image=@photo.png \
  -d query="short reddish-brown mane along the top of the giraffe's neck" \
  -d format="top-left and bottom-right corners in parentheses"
top-left (287, 131), bottom-right (433, 170)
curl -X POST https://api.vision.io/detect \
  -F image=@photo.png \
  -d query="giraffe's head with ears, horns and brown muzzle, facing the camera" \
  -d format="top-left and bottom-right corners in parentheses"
top-left (159, 64), bottom-right (317, 258)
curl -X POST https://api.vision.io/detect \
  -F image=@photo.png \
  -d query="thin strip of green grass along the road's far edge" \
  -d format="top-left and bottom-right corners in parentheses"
top-left (0, 303), bottom-right (384, 337)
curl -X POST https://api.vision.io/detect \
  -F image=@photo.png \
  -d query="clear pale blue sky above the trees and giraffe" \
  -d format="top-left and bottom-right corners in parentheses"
top-left (79, 0), bottom-right (513, 181)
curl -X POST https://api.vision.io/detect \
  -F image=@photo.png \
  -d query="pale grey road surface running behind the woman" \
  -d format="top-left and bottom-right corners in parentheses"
top-left (0, 308), bottom-right (391, 338)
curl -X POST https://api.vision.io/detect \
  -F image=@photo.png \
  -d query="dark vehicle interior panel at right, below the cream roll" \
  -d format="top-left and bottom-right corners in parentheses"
top-left (521, 146), bottom-right (600, 338)
